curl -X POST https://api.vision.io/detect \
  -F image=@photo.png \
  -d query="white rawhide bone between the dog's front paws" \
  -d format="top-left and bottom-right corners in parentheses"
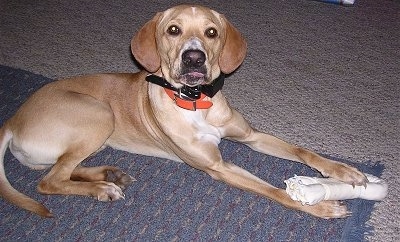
top-left (285, 174), bottom-right (388, 205)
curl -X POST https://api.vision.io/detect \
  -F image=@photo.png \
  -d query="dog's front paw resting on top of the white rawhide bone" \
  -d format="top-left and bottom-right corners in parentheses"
top-left (322, 162), bottom-right (368, 186)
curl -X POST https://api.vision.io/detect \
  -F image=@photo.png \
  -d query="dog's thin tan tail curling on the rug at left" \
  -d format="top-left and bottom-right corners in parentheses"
top-left (0, 126), bottom-right (53, 217)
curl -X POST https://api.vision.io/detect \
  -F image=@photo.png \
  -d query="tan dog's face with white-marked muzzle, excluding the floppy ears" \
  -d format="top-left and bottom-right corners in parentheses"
top-left (156, 7), bottom-right (225, 86)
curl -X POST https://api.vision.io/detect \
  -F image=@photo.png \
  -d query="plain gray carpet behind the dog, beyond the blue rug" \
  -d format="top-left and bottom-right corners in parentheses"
top-left (0, 0), bottom-right (400, 241)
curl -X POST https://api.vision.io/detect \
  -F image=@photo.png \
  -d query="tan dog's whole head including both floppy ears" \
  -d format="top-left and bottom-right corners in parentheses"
top-left (131, 5), bottom-right (246, 87)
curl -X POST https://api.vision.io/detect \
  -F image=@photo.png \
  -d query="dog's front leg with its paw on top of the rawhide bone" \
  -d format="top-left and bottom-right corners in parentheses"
top-left (224, 108), bottom-right (367, 186)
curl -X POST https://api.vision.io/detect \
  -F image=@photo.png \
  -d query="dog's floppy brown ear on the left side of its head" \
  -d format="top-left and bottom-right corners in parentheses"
top-left (131, 13), bottom-right (161, 73)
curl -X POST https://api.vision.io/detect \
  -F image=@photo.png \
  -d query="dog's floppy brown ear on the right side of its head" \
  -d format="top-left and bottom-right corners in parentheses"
top-left (219, 16), bottom-right (247, 74)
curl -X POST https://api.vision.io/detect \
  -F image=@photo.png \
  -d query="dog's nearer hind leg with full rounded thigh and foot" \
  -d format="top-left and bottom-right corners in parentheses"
top-left (6, 86), bottom-right (123, 201)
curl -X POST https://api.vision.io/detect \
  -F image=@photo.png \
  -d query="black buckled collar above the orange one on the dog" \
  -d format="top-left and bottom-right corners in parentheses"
top-left (146, 73), bottom-right (225, 100)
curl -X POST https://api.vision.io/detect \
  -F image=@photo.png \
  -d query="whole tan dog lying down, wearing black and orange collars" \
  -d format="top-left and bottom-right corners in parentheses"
top-left (0, 5), bottom-right (367, 218)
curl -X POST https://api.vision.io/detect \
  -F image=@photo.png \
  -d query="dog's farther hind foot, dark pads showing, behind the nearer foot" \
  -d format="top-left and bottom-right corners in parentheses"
top-left (71, 166), bottom-right (135, 190)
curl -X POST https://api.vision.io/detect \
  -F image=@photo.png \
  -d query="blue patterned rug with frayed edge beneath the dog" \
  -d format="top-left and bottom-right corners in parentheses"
top-left (0, 66), bottom-right (384, 242)
